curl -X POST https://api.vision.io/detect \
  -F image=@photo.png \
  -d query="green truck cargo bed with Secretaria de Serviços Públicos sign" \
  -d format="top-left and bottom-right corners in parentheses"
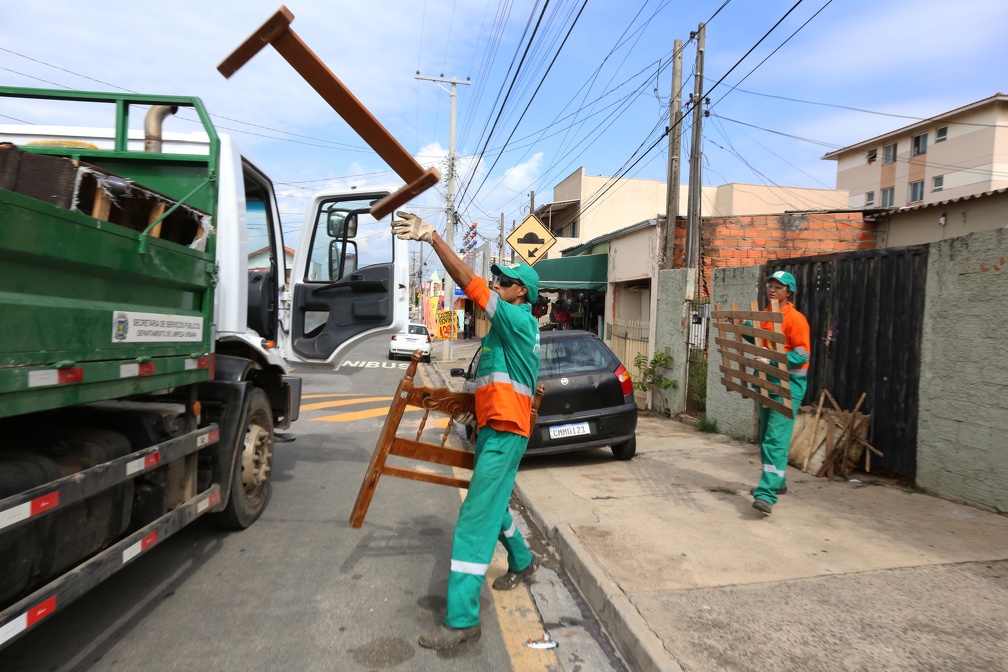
top-left (0, 89), bottom-right (216, 417)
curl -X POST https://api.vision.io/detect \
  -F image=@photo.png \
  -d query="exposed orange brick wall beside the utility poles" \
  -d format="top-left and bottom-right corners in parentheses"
top-left (672, 212), bottom-right (877, 295)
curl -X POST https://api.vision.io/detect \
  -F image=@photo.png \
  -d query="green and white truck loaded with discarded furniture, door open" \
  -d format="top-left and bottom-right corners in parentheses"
top-left (0, 88), bottom-right (408, 648)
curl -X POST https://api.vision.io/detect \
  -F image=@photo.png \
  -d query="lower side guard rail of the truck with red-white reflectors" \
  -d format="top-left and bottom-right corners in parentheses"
top-left (0, 483), bottom-right (221, 649)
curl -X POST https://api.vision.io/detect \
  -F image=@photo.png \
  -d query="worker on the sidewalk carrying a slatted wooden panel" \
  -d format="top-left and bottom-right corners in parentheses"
top-left (750, 271), bottom-right (811, 515)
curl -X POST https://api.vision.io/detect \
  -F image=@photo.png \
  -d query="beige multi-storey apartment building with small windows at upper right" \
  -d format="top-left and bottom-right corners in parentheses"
top-left (823, 93), bottom-right (1008, 210)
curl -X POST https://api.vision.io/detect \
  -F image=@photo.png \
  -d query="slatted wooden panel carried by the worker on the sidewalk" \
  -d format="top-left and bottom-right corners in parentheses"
top-left (711, 300), bottom-right (793, 418)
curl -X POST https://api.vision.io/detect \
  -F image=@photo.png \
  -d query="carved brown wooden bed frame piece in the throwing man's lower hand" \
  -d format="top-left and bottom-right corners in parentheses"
top-left (350, 350), bottom-right (545, 528)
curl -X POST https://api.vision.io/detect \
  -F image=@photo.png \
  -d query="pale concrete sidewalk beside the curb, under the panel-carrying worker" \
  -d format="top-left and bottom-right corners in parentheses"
top-left (434, 341), bottom-right (1008, 672)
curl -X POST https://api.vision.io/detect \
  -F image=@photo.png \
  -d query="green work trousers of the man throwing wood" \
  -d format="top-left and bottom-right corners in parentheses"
top-left (445, 425), bottom-right (532, 628)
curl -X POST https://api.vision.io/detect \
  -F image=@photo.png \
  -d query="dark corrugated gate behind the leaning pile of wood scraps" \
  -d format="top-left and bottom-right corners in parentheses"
top-left (760, 245), bottom-right (927, 483)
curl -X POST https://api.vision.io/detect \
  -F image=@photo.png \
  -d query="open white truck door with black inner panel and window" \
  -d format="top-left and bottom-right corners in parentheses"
top-left (284, 191), bottom-right (409, 367)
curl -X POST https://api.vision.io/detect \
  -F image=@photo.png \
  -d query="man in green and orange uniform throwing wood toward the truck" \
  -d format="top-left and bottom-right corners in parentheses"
top-left (392, 213), bottom-right (539, 650)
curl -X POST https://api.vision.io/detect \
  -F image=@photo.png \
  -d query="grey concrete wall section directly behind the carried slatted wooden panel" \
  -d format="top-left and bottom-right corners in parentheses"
top-left (707, 266), bottom-right (760, 440)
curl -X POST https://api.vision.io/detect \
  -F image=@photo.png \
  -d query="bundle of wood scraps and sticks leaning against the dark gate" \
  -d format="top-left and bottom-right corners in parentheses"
top-left (788, 390), bottom-right (882, 479)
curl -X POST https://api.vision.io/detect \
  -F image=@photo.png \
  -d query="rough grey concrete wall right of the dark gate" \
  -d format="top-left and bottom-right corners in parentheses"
top-left (916, 230), bottom-right (1008, 513)
